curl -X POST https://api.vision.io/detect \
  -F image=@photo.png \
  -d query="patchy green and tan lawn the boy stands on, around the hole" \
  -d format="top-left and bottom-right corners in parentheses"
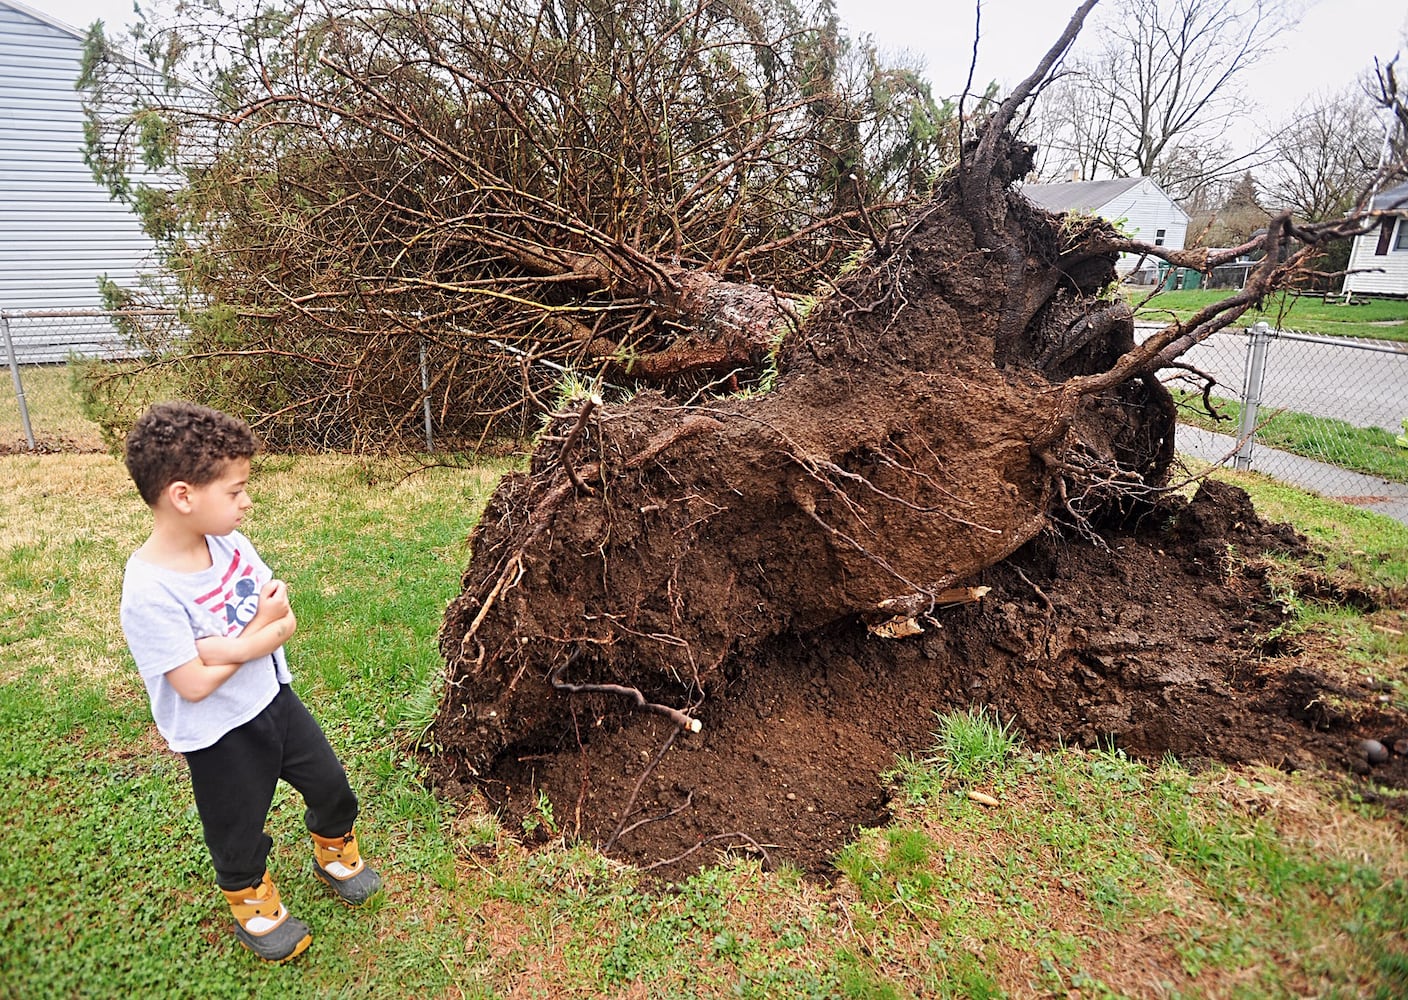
top-left (0, 371), bottom-right (1408, 1000)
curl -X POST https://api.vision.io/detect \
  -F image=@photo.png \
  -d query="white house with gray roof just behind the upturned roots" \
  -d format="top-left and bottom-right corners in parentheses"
top-left (1021, 177), bottom-right (1188, 285)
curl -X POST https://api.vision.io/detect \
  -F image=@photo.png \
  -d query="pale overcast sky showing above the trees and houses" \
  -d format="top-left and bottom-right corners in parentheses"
top-left (21, 0), bottom-right (1408, 148)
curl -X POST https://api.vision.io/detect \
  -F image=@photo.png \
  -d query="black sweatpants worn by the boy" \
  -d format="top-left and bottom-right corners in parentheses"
top-left (186, 685), bottom-right (358, 890)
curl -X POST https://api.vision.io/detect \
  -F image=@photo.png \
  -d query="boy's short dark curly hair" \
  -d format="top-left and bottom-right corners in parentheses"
top-left (124, 401), bottom-right (258, 507)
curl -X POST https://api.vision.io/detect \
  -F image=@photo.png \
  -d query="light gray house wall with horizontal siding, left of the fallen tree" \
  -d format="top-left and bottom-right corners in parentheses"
top-left (0, 0), bottom-right (152, 362)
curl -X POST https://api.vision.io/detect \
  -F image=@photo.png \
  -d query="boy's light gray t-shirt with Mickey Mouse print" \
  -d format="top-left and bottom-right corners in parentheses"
top-left (121, 531), bottom-right (291, 754)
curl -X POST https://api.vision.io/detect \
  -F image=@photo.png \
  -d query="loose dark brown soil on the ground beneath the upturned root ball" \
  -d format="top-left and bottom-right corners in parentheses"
top-left (431, 482), bottom-right (1408, 877)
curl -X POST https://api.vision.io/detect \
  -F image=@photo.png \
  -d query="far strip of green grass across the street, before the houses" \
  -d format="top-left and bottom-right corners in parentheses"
top-left (1124, 287), bottom-right (1408, 341)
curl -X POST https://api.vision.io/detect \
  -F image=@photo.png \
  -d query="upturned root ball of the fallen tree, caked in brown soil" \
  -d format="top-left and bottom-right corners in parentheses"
top-left (436, 1), bottom-right (1402, 770)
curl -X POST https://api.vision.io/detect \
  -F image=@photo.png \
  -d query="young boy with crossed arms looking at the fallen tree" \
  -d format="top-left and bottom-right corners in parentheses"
top-left (121, 403), bottom-right (382, 962)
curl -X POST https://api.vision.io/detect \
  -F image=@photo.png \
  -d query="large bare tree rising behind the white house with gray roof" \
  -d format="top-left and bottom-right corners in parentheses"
top-left (1036, 0), bottom-right (1293, 197)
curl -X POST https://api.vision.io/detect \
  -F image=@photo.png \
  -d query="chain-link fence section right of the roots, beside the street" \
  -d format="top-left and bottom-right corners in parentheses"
top-left (1170, 323), bottom-right (1408, 497)
